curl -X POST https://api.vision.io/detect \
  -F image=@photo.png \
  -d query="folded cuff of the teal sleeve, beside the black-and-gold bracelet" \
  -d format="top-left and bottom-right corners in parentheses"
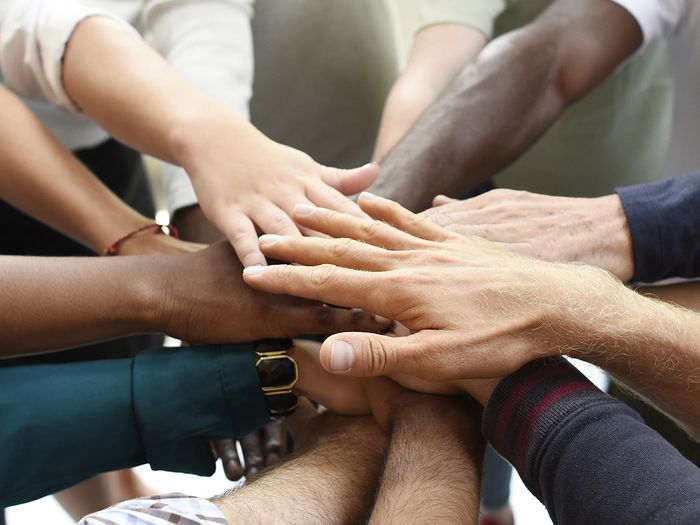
top-left (133, 344), bottom-right (270, 476)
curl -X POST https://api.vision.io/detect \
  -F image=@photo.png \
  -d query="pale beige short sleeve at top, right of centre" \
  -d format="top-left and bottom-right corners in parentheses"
top-left (396, 0), bottom-right (507, 38)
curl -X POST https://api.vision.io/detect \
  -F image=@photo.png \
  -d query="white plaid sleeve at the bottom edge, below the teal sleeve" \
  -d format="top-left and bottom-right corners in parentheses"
top-left (78, 494), bottom-right (228, 525)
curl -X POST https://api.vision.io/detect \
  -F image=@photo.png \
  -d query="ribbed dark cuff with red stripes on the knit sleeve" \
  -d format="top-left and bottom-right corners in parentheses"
top-left (482, 358), bottom-right (616, 500)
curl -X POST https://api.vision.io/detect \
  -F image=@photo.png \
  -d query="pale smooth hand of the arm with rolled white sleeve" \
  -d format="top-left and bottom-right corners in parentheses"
top-left (180, 115), bottom-right (379, 266)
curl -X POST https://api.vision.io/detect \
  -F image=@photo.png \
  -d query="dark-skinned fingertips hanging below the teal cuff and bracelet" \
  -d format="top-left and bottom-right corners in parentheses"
top-left (213, 420), bottom-right (287, 481)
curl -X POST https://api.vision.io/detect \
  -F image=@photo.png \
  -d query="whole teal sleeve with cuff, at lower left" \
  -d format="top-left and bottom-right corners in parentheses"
top-left (0, 345), bottom-right (269, 507)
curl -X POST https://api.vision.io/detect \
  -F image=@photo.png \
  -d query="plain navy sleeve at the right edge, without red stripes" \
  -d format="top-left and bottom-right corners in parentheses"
top-left (617, 171), bottom-right (700, 283)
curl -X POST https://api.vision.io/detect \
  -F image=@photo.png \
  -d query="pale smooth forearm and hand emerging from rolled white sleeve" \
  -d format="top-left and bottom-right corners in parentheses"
top-left (62, 17), bottom-right (378, 266)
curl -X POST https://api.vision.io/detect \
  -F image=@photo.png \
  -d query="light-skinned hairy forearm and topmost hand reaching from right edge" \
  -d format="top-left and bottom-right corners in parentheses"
top-left (244, 194), bottom-right (700, 439)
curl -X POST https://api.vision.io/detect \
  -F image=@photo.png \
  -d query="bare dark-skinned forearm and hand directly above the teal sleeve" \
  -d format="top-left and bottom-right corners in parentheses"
top-left (0, 243), bottom-right (386, 357)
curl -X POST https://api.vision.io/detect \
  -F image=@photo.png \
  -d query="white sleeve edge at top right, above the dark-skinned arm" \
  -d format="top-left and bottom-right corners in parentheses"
top-left (612, 0), bottom-right (697, 45)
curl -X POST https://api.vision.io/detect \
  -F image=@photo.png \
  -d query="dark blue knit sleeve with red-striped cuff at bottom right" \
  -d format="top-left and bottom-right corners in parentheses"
top-left (483, 359), bottom-right (700, 525)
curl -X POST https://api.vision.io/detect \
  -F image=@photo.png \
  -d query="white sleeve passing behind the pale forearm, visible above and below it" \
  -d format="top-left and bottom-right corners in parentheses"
top-left (141, 0), bottom-right (254, 212)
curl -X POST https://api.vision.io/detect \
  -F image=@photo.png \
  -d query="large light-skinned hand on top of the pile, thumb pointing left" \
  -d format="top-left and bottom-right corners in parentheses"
top-left (244, 194), bottom-right (619, 381)
